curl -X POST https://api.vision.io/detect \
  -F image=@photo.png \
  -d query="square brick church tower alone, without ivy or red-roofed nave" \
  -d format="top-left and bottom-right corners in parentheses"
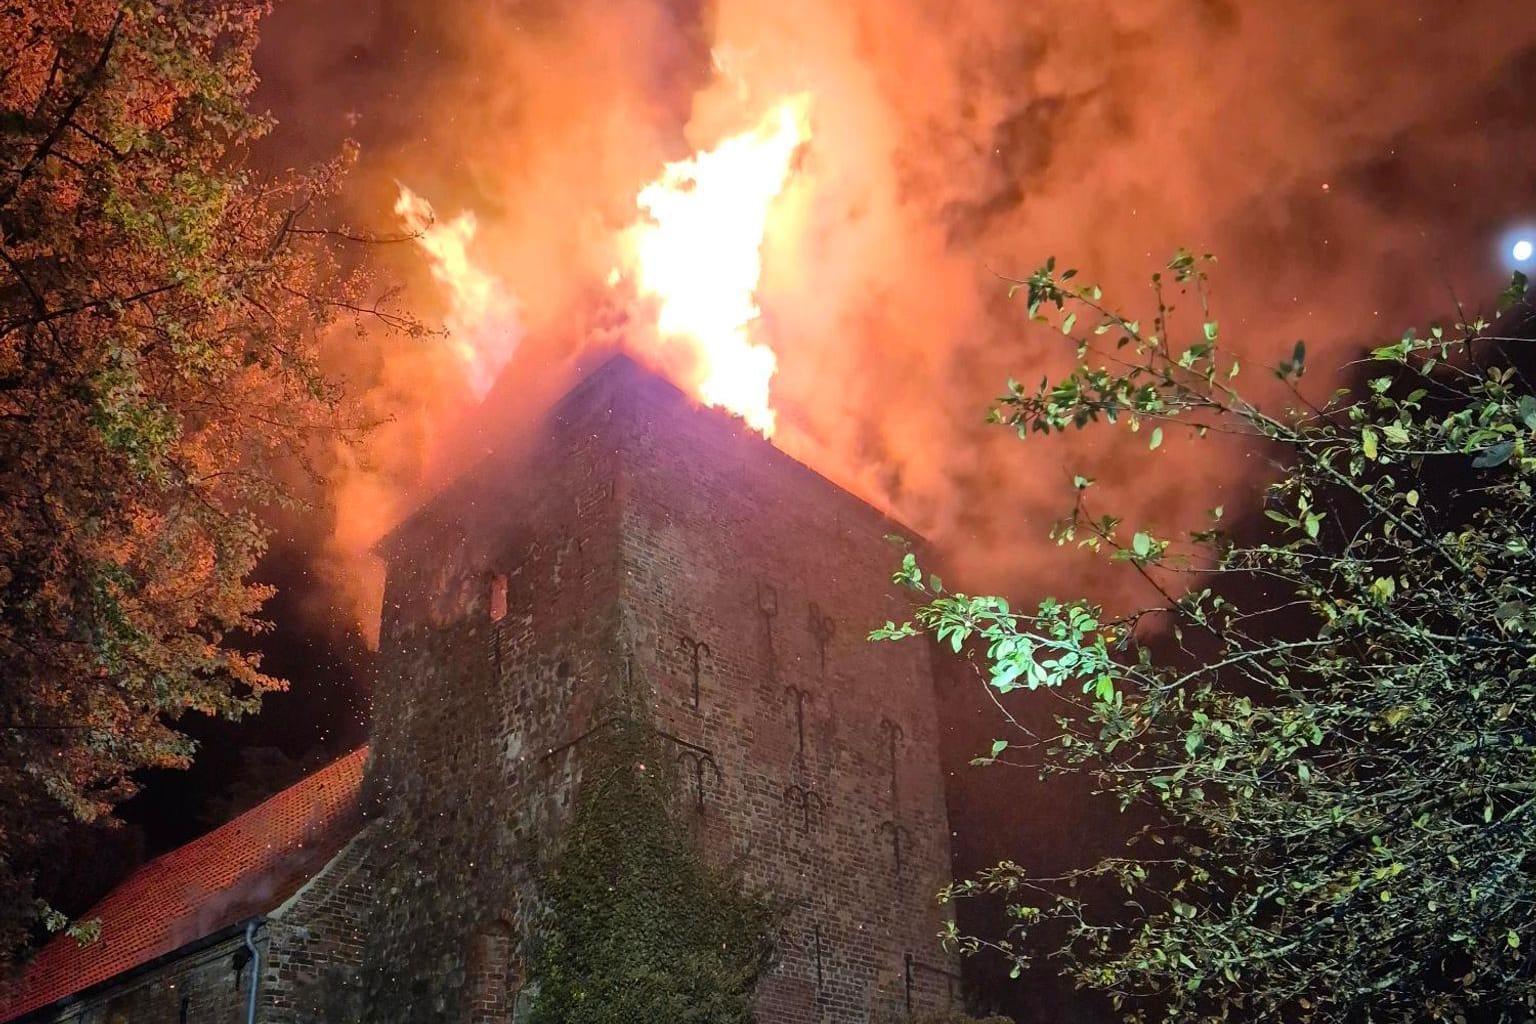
top-left (362, 356), bottom-right (958, 1024)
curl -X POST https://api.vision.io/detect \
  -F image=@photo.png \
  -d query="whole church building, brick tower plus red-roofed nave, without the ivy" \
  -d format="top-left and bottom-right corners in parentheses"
top-left (0, 356), bottom-right (960, 1024)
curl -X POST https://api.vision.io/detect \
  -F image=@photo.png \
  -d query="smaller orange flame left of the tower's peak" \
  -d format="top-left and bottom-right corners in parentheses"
top-left (395, 186), bottom-right (519, 399)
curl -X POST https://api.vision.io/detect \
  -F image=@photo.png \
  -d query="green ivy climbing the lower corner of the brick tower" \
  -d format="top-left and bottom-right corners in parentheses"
top-left (530, 725), bottom-right (779, 1024)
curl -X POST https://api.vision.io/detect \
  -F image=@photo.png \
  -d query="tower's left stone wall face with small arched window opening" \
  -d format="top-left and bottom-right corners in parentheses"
top-left (351, 369), bottom-right (622, 1024)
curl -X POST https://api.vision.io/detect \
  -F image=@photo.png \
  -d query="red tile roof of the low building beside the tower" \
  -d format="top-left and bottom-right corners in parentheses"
top-left (0, 746), bottom-right (367, 1022)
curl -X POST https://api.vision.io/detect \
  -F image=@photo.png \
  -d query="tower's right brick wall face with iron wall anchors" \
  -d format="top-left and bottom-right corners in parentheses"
top-left (622, 363), bottom-right (958, 1024)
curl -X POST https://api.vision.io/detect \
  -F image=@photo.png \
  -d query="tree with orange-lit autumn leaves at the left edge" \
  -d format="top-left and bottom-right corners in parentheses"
top-left (0, 0), bottom-right (402, 955)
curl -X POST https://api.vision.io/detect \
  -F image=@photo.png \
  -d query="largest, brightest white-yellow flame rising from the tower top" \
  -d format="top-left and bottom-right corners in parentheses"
top-left (610, 95), bottom-right (811, 434)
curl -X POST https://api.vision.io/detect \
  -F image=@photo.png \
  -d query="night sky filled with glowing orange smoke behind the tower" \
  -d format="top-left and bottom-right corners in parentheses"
top-left (69, 0), bottom-right (1536, 1019)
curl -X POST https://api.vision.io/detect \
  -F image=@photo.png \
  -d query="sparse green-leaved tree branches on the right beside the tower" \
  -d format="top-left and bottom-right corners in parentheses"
top-left (872, 253), bottom-right (1536, 1022)
